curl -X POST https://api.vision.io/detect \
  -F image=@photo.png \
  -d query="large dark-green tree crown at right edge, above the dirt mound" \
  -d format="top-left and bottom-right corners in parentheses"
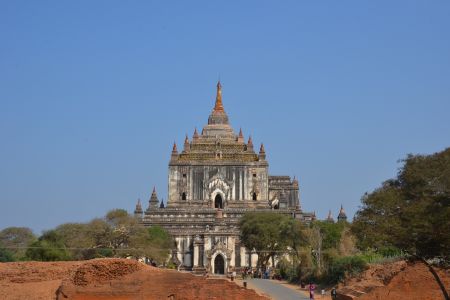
top-left (352, 148), bottom-right (450, 262)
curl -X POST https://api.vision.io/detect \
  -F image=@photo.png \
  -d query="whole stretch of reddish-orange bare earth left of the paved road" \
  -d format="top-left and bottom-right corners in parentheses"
top-left (0, 259), bottom-right (267, 300)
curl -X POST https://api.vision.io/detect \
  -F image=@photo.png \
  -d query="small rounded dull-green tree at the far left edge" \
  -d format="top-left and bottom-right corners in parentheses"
top-left (0, 227), bottom-right (36, 260)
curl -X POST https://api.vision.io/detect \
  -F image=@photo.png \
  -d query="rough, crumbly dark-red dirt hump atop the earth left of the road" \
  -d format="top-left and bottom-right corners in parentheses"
top-left (71, 259), bottom-right (145, 286)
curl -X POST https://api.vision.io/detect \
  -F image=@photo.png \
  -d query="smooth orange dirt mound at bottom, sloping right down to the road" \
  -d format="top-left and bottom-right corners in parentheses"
top-left (57, 267), bottom-right (266, 300)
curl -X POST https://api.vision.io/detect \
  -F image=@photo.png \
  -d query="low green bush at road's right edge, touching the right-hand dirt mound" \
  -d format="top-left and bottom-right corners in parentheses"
top-left (327, 255), bottom-right (367, 283)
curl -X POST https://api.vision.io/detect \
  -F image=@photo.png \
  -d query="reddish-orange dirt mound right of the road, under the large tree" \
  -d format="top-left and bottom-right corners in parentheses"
top-left (338, 261), bottom-right (450, 300)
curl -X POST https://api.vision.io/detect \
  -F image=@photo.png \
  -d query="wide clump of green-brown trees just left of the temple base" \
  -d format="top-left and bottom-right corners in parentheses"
top-left (19, 209), bottom-right (172, 263)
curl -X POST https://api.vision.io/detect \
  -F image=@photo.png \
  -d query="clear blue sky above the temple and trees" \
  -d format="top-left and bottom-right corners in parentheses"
top-left (0, 0), bottom-right (450, 233)
